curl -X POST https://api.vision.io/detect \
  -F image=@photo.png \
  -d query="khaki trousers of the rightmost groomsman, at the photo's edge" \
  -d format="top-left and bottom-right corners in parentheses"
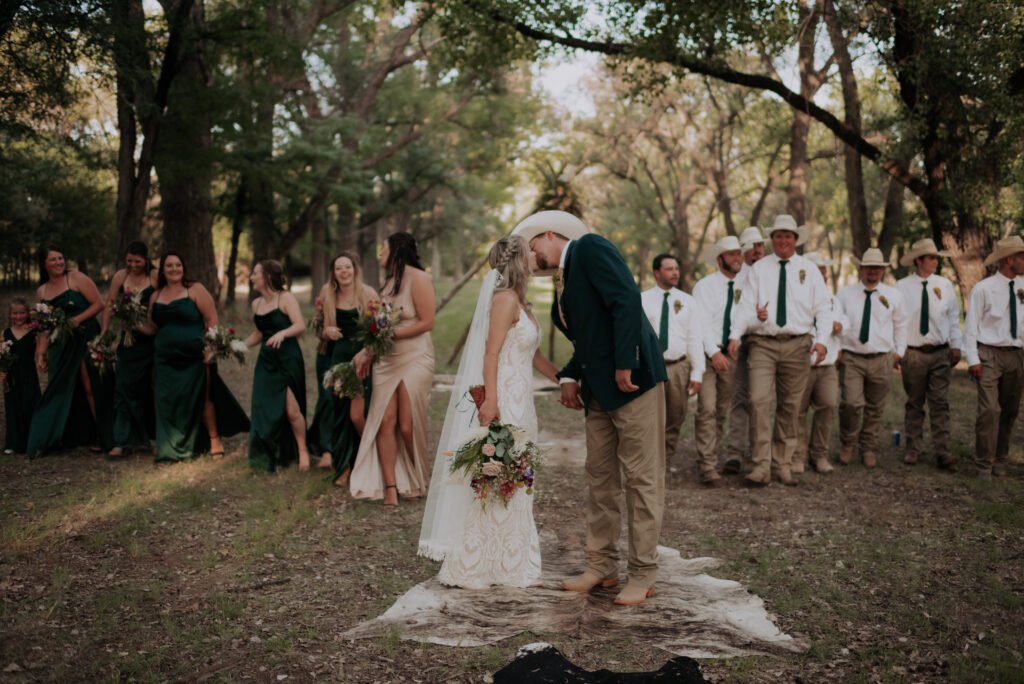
top-left (974, 344), bottom-right (1024, 471)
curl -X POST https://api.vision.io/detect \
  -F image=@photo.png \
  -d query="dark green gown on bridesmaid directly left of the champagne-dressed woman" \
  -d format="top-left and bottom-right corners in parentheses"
top-left (309, 309), bottom-right (373, 478)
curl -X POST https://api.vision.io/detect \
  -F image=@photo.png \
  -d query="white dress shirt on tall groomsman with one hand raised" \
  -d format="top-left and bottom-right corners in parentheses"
top-left (729, 254), bottom-right (833, 345)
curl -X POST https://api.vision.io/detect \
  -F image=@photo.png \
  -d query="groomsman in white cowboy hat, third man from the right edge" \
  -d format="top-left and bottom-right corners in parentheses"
top-left (836, 247), bottom-right (906, 468)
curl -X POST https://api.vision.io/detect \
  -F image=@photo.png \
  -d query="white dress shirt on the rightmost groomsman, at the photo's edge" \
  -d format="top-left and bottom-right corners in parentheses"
top-left (964, 273), bottom-right (1024, 366)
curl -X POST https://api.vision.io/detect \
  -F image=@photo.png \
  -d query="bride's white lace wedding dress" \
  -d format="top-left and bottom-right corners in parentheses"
top-left (437, 311), bottom-right (541, 589)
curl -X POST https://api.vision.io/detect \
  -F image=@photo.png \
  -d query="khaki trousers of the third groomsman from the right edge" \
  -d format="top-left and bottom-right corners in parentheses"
top-left (839, 350), bottom-right (893, 458)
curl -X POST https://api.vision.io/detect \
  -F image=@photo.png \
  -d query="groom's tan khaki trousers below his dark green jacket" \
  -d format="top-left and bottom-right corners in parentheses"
top-left (585, 383), bottom-right (665, 587)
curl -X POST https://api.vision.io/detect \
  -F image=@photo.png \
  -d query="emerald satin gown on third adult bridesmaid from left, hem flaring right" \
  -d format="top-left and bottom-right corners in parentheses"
top-left (151, 297), bottom-right (249, 463)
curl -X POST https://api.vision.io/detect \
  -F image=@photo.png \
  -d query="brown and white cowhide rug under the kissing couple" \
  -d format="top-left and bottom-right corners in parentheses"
top-left (343, 531), bottom-right (809, 657)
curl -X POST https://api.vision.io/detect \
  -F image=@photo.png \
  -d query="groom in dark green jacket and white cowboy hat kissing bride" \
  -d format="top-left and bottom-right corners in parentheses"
top-left (514, 211), bottom-right (667, 605)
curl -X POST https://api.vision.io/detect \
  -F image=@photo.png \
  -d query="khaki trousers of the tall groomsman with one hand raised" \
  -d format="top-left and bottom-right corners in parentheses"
top-left (749, 335), bottom-right (811, 478)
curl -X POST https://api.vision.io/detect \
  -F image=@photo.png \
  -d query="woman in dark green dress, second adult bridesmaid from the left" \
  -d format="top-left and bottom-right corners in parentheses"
top-left (102, 241), bottom-right (157, 459)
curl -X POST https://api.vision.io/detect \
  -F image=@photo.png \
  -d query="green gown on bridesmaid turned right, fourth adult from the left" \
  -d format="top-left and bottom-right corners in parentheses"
top-left (249, 308), bottom-right (306, 472)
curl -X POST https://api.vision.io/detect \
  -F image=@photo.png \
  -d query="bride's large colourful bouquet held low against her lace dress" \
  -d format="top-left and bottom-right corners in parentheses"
top-left (450, 421), bottom-right (543, 508)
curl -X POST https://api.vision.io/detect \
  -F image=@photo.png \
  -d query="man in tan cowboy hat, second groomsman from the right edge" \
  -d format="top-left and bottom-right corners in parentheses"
top-left (896, 238), bottom-right (964, 468)
